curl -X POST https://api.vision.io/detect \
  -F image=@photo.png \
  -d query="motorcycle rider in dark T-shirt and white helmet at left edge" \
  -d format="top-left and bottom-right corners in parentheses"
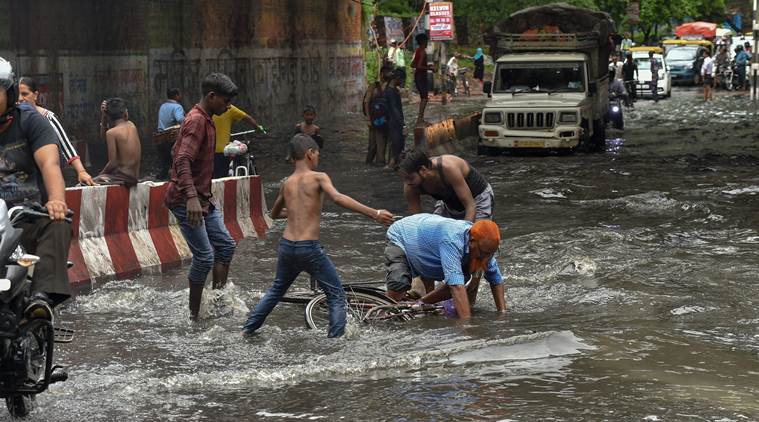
top-left (0, 58), bottom-right (71, 306)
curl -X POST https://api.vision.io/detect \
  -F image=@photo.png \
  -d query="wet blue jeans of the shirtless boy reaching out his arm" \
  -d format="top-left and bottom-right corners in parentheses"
top-left (242, 238), bottom-right (345, 337)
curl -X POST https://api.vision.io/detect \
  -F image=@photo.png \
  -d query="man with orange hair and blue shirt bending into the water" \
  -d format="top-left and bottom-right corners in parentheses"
top-left (385, 214), bottom-right (506, 318)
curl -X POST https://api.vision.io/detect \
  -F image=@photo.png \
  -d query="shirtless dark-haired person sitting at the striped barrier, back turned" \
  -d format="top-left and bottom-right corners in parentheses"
top-left (92, 97), bottom-right (142, 188)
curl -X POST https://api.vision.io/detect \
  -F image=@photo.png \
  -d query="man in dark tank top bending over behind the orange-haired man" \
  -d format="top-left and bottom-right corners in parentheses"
top-left (399, 150), bottom-right (494, 222)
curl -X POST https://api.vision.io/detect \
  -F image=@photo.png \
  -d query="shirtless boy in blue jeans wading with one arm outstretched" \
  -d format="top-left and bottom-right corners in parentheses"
top-left (242, 134), bottom-right (393, 337)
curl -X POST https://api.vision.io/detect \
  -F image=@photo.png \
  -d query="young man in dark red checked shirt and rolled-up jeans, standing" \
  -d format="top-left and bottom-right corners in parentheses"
top-left (165, 73), bottom-right (237, 320)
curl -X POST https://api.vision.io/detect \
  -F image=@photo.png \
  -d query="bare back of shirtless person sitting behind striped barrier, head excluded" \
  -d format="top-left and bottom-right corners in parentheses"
top-left (97, 120), bottom-right (142, 186)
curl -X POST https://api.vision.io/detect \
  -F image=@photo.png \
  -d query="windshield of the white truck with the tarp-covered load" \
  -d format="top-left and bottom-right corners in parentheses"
top-left (493, 62), bottom-right (585, 93)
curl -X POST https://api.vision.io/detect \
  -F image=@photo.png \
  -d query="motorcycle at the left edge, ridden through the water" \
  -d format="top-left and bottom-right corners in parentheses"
top-left (0, 200), bottom-right (74, 417)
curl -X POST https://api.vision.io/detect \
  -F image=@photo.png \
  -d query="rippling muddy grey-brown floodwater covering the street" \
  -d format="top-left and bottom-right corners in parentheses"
top-left (13, 88), bottom-right (759, 421)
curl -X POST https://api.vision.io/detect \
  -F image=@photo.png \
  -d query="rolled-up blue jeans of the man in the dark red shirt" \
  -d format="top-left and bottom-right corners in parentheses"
top-left (171, 205), bottom-right (237, 285)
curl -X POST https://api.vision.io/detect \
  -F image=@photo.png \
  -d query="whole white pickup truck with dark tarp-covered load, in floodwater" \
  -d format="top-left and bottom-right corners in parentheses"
top-left (478, 4), bottom-right (613, 153)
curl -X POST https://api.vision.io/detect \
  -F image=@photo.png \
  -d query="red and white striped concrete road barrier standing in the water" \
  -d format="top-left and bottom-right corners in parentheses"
top-left (66, 176), bottom-right (271, 283)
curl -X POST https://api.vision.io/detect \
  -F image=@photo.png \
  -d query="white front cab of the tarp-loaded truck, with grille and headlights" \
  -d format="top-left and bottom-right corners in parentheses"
top-left (479, 53), bottom-right (593, 150)
